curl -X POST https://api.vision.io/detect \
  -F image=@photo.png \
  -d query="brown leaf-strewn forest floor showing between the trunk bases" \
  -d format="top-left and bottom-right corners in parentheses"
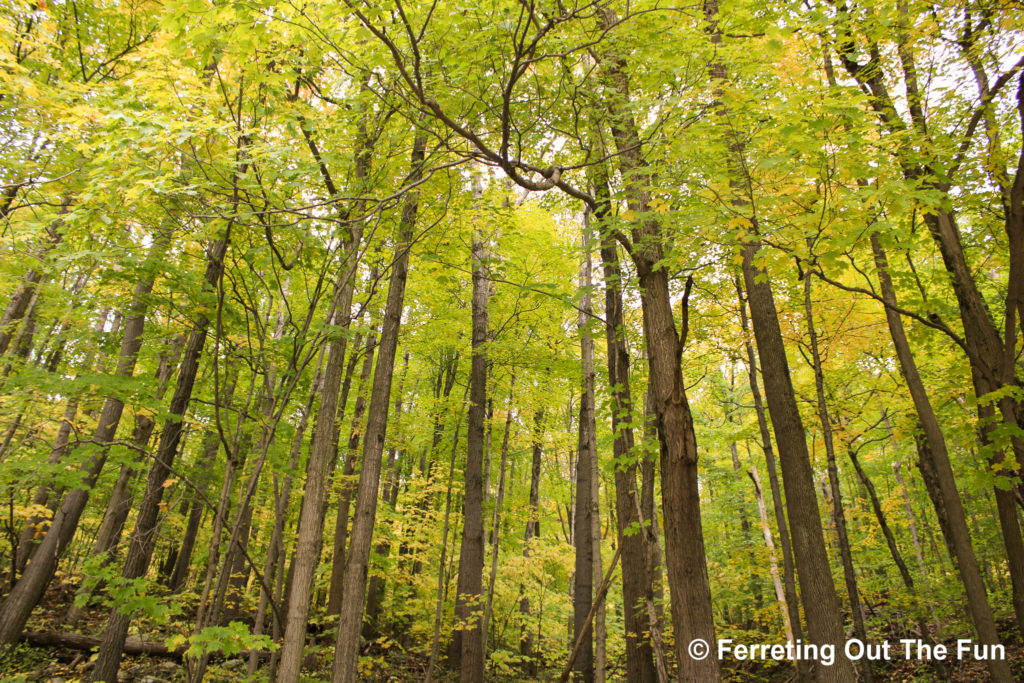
top-left (0, 584), bottom-right (1024, 683)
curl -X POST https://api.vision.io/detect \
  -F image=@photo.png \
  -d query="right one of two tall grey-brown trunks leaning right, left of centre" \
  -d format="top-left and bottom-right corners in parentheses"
top-left (334, 133), bottom-right (426, 682)
